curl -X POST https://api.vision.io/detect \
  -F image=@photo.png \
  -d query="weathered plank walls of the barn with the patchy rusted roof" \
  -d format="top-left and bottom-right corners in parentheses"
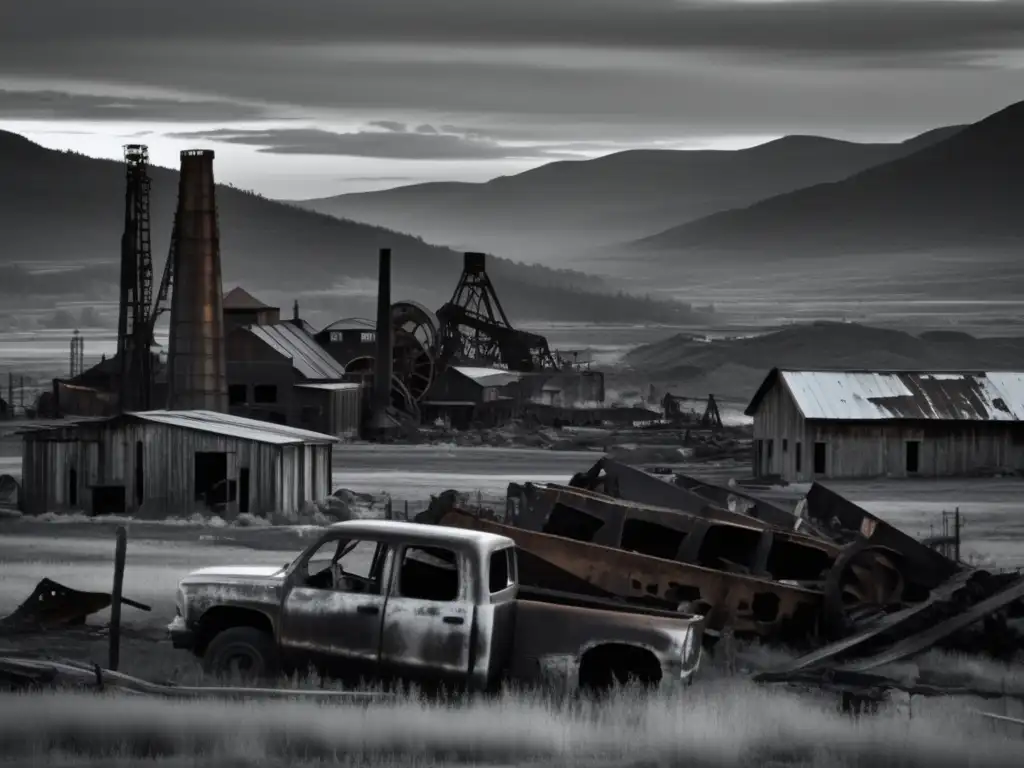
top-left (753, 382), bottom-right (1024, 482)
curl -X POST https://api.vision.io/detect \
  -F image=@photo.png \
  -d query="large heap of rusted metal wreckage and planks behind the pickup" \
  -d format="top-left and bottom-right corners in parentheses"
top-left (417, 457), bottom-right (1024, 700)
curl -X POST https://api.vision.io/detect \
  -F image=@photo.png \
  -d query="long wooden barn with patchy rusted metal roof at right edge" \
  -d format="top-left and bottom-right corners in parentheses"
top-left (745, 369), bottom-right (1024, 482)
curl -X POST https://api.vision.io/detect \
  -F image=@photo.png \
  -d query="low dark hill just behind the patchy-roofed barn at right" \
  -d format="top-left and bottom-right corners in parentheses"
top-left (623, 323), bottom-right (1024, 399)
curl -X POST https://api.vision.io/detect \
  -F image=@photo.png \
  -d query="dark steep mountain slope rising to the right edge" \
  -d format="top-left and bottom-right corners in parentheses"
top-left (636, 97), bottom-right (1024, 258)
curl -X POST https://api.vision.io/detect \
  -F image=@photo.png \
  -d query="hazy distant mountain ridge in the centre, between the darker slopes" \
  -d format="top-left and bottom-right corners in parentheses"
top-left (300, 127), bottom-right (958, 264)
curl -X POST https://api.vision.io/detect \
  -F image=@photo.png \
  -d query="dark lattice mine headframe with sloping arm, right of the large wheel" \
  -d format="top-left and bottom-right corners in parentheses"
top-left (437, 253), bottom-right (558, 372)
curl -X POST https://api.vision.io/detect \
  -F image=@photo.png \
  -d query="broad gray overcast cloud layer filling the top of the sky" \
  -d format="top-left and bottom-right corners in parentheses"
top-left (0, 0), bottom-right (1024, 160)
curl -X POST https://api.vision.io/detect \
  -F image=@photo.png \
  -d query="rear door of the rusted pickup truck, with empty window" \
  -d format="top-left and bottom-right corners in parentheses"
top-left (381, 546), bottom-right (474, 683)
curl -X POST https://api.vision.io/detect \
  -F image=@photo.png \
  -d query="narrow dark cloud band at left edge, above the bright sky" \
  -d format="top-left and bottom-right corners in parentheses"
top-left (0, 89), bottom-right (282, 123)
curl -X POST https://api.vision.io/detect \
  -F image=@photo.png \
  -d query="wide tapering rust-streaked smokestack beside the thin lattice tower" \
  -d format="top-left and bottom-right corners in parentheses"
top-left (167, 150), bottom-right (227, 412)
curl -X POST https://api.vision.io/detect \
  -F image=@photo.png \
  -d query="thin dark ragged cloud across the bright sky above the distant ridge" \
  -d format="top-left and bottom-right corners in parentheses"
top-left (170, 126), bottom-right (577, 160)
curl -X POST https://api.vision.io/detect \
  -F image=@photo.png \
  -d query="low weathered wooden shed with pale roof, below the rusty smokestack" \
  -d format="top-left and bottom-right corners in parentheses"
top-left (22, 411), bottom-right (337, 519)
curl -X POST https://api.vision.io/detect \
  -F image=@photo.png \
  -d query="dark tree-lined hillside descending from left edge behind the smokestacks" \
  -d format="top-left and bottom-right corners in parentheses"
top-left (0, 132), bottom-right (685, 322)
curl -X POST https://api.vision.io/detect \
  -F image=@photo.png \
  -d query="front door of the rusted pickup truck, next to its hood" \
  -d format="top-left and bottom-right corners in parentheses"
top-left (281, 539), bottom-right (392, 678)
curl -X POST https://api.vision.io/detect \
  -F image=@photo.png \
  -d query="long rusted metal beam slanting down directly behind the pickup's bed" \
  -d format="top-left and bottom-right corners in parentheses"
top-left (434, 508), bottom-right (820, 642)
